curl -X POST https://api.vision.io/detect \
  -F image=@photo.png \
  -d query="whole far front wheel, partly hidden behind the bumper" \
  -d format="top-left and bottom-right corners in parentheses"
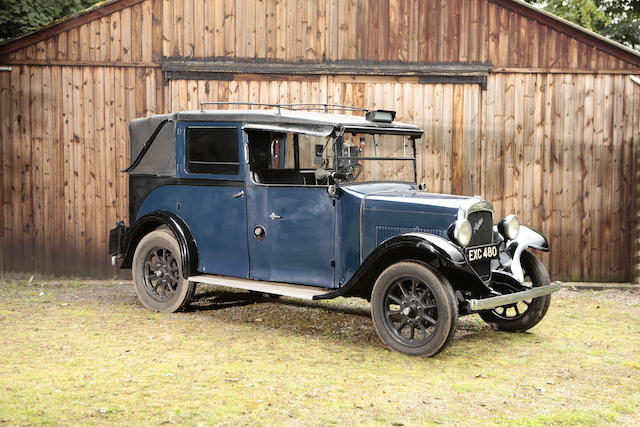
top-left (479, 251), bottom-right (551, 332)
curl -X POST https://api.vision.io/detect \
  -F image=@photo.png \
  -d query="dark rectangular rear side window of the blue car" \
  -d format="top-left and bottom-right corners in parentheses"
top-left (187, 127), bottom-right (240, 175)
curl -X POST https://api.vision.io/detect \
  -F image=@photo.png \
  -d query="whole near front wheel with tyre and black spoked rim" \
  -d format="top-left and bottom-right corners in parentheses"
top-left (371, 262), bottom-right (458, 356)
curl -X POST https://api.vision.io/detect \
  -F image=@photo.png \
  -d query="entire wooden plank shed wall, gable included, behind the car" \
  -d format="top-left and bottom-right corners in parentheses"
top-left (0, 0), bottom-right (640, 280)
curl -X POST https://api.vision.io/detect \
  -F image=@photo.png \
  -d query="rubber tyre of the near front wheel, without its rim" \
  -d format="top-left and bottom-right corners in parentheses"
top-left (371, 261), bottom-right (458, 357)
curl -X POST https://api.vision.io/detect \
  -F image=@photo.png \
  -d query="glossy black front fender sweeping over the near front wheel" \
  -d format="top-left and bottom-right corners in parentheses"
top-left (316, 232), bottom-right (466, 299)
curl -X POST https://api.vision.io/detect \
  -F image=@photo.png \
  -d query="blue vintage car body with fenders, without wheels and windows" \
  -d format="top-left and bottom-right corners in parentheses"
top-left (111, 111), bottom-right (548, 306)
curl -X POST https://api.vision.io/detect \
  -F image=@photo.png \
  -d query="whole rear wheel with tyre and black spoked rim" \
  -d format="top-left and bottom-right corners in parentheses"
top-left (132, 229), bottom-right (195, 312)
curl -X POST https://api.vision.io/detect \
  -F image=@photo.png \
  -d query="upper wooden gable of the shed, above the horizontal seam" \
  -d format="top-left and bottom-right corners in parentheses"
top-left (0, 0), bottom-right (640, 70)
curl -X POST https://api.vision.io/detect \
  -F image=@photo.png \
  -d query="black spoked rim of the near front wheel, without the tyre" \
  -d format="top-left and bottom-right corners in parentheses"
top-left (383, 277), bottom-right (439, 347)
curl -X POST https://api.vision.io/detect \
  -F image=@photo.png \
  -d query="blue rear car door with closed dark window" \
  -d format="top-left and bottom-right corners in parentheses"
top-left (172, 122), bottom-right (249, 277)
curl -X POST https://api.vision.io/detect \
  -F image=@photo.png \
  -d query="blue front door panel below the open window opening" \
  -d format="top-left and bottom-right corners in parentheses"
top-left (247, 185), bottom-right (336, 287)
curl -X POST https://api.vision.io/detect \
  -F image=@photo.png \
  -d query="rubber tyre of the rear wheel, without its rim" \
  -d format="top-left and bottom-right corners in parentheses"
top-left (132, 228), bottom-right (196, 313)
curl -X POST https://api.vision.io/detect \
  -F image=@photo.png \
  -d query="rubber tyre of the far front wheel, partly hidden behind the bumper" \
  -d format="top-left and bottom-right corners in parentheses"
top-left (478, 251), bottom-right (551, 332)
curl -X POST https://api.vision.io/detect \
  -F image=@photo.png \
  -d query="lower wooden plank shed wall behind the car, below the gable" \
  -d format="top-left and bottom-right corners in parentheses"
top-left (0, 66), bottom-right (640, 280)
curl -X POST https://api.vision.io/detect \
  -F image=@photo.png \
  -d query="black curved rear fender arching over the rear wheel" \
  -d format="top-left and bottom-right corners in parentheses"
top-left (120, 211), bottom-right (198, 279)
